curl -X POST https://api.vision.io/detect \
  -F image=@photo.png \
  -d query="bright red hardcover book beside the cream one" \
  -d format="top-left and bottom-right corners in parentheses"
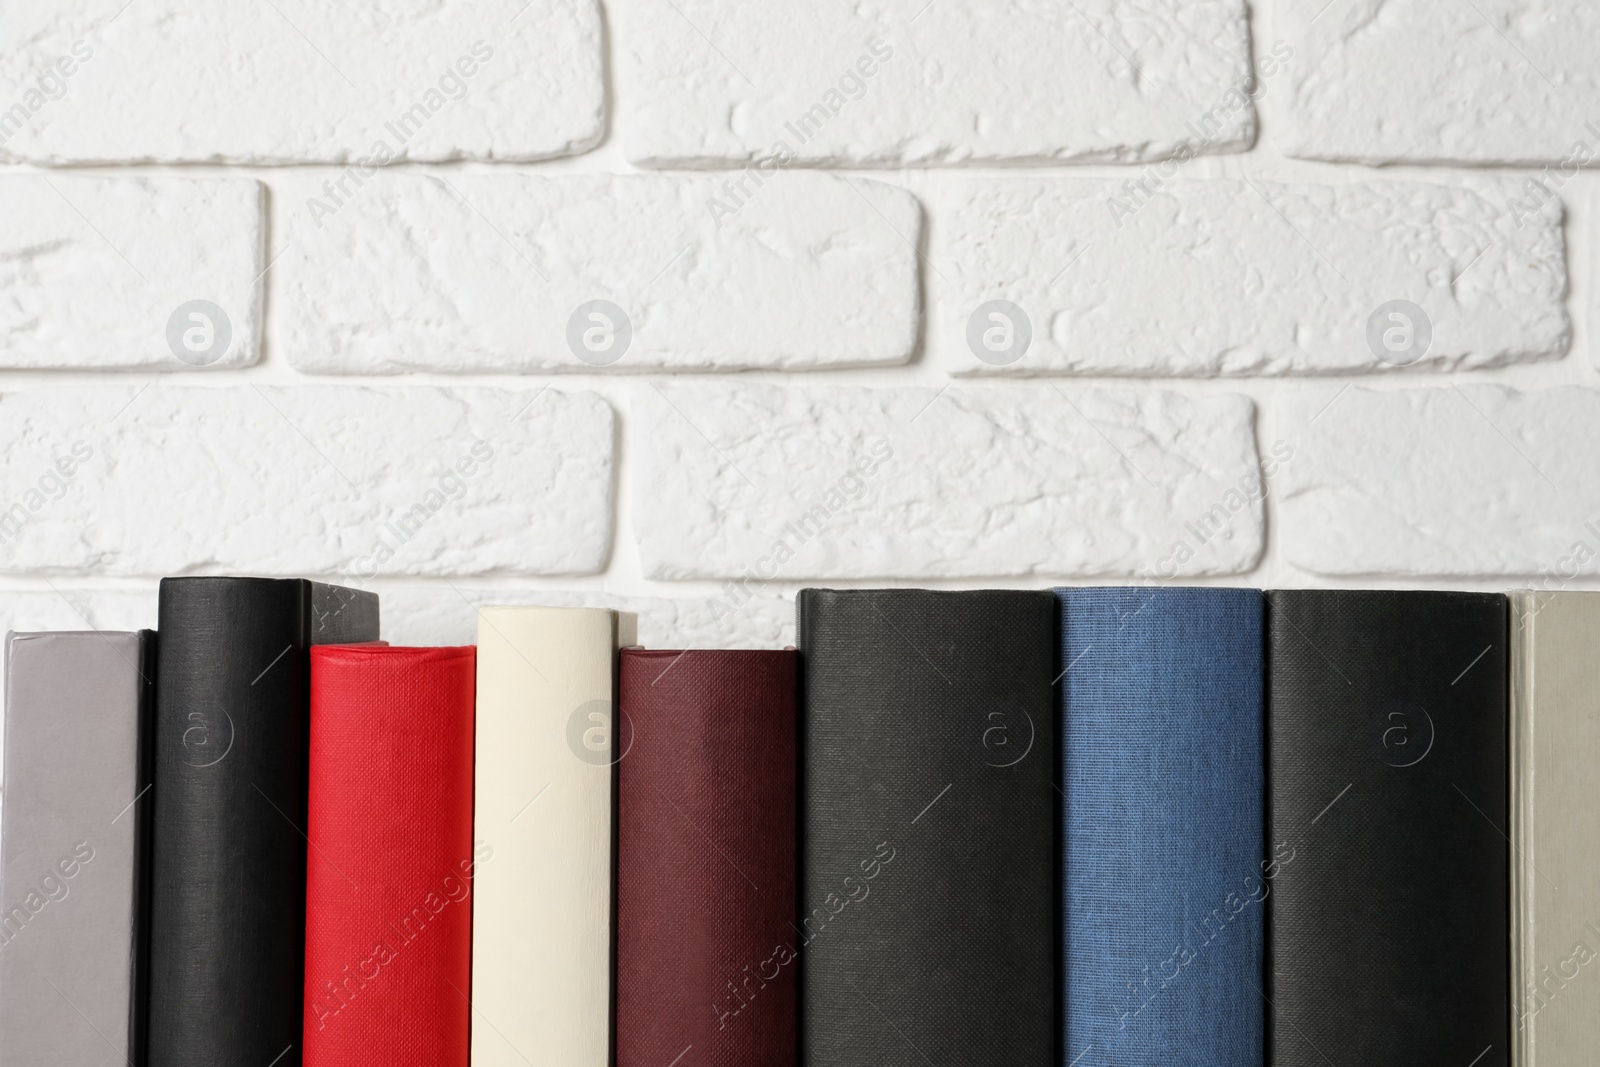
top-left (300, 645), bottom-right (477, 1067)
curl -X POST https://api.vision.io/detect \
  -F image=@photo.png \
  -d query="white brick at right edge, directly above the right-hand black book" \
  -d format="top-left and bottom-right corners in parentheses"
top-left (1275, 386), bottom-right (1600, 587)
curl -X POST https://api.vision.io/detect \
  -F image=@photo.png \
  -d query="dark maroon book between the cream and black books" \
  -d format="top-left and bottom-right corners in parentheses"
top-left (616, 649), bottom-right (798, 1067)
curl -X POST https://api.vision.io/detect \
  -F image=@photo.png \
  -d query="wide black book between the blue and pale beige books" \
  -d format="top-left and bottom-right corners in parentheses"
top-left (1266, 590), bottom-right (1510, 1067)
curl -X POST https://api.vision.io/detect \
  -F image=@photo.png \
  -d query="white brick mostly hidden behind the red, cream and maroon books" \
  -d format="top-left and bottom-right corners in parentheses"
top-left (371, 582), bottom-right (795, 648)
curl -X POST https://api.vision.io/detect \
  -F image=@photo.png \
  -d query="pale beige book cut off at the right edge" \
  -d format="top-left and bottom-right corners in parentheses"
top-left (1512, 592), bottom-right (1600, 1067)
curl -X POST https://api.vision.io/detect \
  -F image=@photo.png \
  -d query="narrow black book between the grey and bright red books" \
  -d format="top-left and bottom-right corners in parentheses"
top-left (149, 577), bottom-right (378, 1067)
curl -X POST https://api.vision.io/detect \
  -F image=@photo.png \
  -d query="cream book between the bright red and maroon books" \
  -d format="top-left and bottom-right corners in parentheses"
top-left (472, 608), bottom-right (637, 1067)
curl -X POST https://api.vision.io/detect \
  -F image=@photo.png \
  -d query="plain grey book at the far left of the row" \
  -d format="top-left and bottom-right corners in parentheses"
top-left (0, 632), bottom-right (155, 1067)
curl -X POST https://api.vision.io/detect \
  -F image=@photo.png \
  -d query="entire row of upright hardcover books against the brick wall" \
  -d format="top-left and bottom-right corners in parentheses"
top-left (0, 577), bottom-right (1600, 1067)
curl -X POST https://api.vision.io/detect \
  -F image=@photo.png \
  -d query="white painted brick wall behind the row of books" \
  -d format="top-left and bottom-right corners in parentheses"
top-left (0, 0), bottom-right (1600, 646)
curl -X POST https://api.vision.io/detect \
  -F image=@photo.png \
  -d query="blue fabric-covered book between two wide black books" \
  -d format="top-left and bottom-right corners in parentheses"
top-left (1056, 589), bottom-right (1270, 1067)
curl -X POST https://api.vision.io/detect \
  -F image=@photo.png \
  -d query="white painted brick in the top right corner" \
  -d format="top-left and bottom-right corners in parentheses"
top-left (1272, 0), bottom-right (1600, 163)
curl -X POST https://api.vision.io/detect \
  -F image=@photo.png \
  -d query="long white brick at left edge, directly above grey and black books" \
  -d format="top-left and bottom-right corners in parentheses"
top-left (0, 386), bottom-right (613, 579)
